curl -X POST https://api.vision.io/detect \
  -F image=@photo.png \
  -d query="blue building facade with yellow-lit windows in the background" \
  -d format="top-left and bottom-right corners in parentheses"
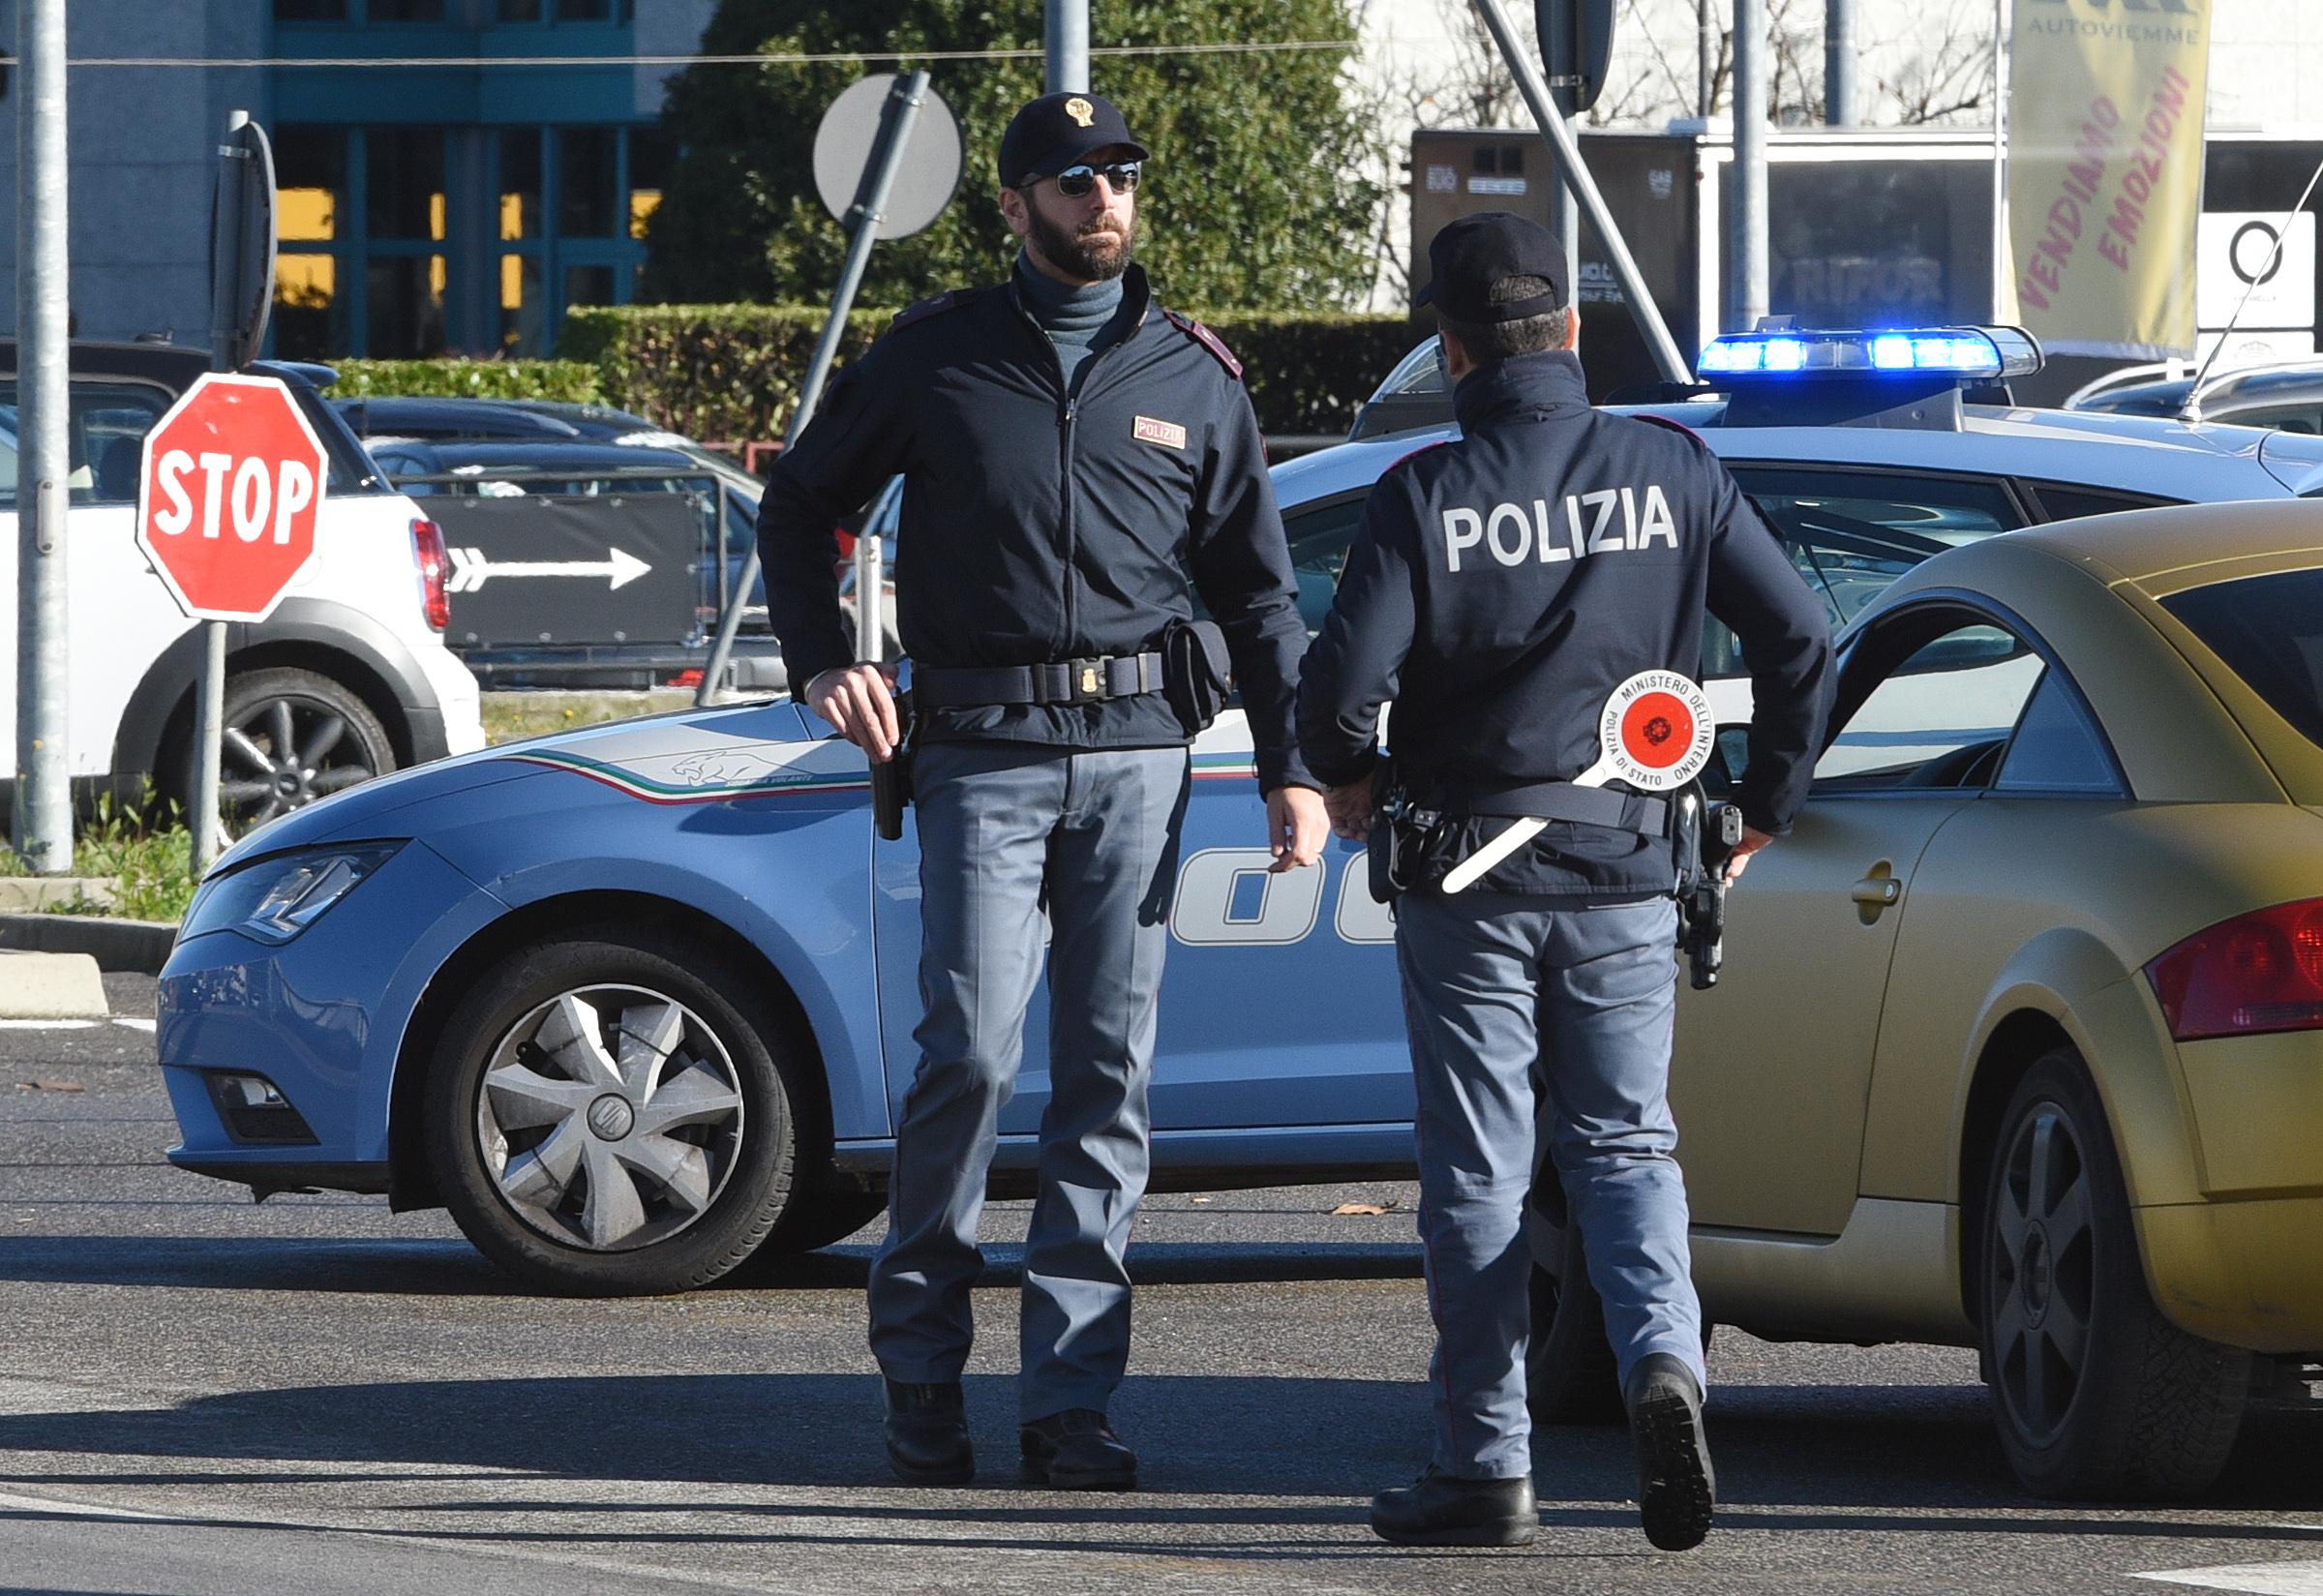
top-left (0, 0), bottom-right (715, 358)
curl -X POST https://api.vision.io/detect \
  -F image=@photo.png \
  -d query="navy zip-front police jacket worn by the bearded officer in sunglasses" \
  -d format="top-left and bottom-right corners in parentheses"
top-left (757, 265), bottom-right (1314, 792)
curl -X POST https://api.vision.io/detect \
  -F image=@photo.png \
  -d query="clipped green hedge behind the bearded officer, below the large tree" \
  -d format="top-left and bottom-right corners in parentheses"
top-left (559, 304), bottom-right (1424, 439)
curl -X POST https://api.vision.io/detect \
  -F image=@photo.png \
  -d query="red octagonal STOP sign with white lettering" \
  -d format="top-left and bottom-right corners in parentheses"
top-left (137, 372), bottom-right (325, 620)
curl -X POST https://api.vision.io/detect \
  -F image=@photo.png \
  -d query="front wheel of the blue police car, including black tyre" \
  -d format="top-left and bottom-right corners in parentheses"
top-left (423, 927), bottom-right (797, 1296)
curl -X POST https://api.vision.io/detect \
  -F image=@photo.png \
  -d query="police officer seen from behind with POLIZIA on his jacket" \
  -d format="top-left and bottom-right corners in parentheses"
top-left (1299, 214), bottom-right (1830, 1550)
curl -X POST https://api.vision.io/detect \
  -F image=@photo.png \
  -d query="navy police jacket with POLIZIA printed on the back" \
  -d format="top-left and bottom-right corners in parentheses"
top-left (1299, 350), bottom-right (1830, 901)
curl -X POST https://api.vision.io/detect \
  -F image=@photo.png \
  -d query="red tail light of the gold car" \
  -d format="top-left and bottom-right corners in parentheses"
top-left (2147, 897), bottom-right (2323, 1040)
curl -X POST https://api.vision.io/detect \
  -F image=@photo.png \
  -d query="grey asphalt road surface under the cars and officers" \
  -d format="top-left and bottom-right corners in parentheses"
top-left (0, 976), bottom-right (2323, 1596)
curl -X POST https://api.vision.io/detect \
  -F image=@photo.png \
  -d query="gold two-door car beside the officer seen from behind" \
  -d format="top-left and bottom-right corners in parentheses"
top-left (1533, 501), bottom-right (2323, 1496)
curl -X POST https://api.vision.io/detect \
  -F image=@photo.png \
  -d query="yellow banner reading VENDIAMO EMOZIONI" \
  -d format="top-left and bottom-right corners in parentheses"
top-left (2009, 0), bottom-right (2212, 360)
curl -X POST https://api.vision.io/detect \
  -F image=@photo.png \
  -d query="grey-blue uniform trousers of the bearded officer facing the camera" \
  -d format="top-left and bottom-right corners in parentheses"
top-left (871, 743), bottom-right (1187, 1422)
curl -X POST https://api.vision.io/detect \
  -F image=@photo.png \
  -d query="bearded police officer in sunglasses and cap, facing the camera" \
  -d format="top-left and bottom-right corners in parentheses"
top-left (757, 93), bottom-right (1329, 1490)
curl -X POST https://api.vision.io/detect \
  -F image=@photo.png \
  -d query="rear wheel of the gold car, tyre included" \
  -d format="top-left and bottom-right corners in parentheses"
top-left (1976, 1048), bottom-right (2251, 1498)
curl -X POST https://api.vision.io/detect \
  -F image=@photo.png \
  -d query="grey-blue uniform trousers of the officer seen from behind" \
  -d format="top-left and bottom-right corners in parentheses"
top-left (1396, 892), bottom-right (1707, 1480)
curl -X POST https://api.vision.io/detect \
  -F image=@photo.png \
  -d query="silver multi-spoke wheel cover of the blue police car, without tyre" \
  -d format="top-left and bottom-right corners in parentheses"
top-left (476, 985), bottom-right (743, 1252)
